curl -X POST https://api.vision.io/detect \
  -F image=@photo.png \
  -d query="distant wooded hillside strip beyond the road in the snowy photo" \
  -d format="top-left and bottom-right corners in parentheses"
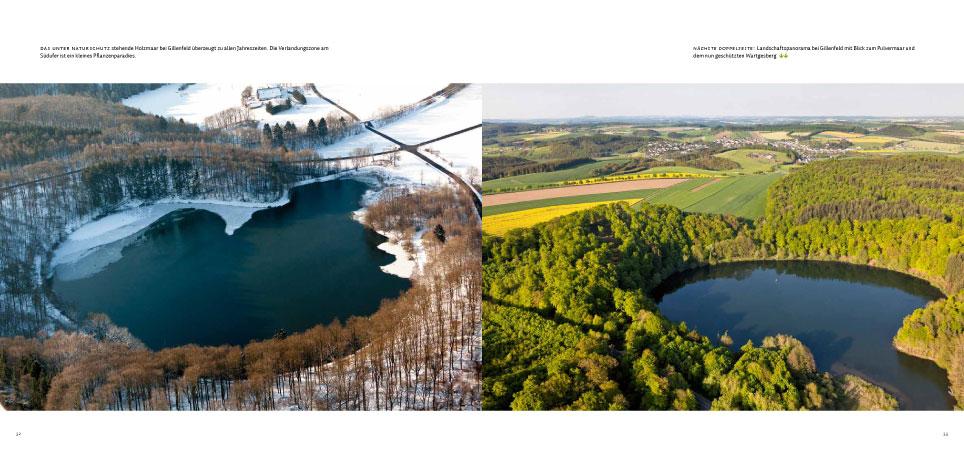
top-left (0, 89), bottom-right (380, 163)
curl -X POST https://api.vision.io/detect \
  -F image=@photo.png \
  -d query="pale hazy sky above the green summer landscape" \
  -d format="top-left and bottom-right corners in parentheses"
top-left (483, 84), bottom-right (964, 120)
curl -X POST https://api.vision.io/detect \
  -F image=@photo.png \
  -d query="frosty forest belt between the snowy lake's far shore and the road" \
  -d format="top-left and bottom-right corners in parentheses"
top-left (0, 142), bottom-right (366, 335)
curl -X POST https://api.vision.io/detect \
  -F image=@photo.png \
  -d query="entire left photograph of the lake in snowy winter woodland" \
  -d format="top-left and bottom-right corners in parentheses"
top-left (0, 82), bottom-right (482, 410)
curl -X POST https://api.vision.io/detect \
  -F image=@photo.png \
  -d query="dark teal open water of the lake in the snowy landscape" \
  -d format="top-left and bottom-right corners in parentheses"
top-left (52, 180), bottom-right (410, 349)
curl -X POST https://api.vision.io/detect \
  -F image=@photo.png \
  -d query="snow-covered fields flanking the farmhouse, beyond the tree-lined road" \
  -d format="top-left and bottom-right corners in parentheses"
top-left (122, 83), bottom-right (446, 127)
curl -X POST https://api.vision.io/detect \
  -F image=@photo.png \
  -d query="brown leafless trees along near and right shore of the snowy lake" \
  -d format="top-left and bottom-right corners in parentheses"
top-left (0, 187), bottom-right (481, 410)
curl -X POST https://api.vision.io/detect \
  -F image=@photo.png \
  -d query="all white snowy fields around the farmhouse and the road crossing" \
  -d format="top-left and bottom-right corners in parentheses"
top-left (123, 84), bottom-right (482, 184)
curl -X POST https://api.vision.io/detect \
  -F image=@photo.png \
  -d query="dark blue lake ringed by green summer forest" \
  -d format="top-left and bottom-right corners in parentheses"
top-left (649, 258), bottom-right (953, 410)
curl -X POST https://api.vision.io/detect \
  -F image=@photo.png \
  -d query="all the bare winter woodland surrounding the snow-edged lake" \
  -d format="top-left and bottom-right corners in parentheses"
top-left (0, 85), bottom-right (481, 410)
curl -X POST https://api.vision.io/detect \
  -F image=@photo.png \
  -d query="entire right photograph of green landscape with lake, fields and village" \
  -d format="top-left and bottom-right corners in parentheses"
top-left (482, 84), bottom-right (964, 411)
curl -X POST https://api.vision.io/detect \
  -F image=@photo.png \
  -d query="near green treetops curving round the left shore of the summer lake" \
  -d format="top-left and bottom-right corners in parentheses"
top-left (483, 204), bottom-right (896, 409)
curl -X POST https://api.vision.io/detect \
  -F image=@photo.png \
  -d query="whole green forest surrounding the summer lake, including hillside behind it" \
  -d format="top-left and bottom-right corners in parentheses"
top-left (483, 157), bottom-right (964, 409)
